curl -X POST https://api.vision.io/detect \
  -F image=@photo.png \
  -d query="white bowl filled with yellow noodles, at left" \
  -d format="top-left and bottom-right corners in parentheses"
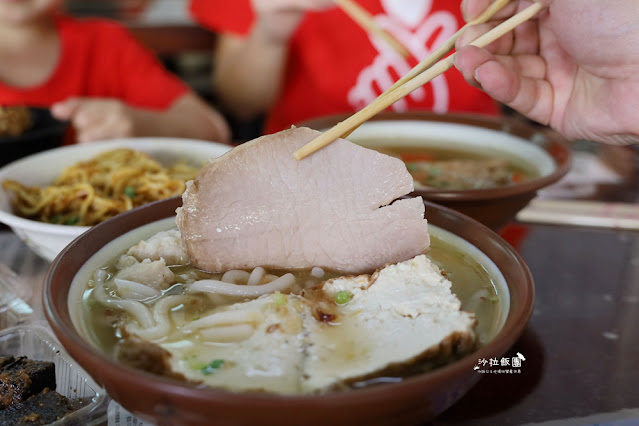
top-left (0, 138), bottom-right (231, 261)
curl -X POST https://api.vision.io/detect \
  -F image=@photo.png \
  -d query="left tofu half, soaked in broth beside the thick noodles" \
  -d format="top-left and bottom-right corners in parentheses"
top-left (160, 295), bottom-right (308, 394)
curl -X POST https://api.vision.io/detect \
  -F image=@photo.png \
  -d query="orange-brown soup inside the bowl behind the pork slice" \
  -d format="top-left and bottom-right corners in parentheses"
top-left (371, 141), bottom-right (539, 190)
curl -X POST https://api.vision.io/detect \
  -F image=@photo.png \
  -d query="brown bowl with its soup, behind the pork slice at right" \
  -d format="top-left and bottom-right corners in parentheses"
top-left (303, 112), bottom-right (571, 229)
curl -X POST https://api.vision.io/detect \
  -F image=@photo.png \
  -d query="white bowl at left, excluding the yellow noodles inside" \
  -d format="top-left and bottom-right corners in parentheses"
top-left (0, 138), bottom-right (231, 261)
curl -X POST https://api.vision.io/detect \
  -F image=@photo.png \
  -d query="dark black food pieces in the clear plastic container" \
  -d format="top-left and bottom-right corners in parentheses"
top-left (0, 355), bottom-right (79, 425)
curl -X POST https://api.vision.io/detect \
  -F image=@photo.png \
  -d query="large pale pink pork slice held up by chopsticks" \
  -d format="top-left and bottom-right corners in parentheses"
top-left (177, 128), bottom-right (429, 273)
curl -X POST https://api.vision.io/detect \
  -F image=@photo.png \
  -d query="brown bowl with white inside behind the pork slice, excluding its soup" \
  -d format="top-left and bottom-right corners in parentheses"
top-left (300, 112), bottom-right (572, 230)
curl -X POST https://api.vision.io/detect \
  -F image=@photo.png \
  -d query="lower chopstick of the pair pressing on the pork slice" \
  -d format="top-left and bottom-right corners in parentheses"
top-left (293, 3), bottom-right (547, 160)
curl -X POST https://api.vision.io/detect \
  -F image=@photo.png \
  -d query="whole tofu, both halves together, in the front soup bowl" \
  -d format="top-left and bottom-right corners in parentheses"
top-left (130, 255), bottom-right (477, 394)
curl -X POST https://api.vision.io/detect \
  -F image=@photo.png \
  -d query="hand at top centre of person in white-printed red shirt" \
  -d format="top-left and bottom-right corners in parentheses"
top-left (251, 0), bottom-right (334, 42)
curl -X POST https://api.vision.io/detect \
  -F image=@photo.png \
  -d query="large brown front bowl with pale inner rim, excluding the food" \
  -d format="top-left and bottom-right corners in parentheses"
top-left (44, 197), bottom-right (534, 425)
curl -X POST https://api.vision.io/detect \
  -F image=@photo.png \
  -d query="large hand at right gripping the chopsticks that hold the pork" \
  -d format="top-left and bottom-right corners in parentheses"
top-left (455, 0), bottom-right (639, 145)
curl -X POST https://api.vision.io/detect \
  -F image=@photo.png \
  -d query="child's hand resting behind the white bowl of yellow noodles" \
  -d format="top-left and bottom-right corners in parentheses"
top-left (51, 98), bottom-right (135, 143)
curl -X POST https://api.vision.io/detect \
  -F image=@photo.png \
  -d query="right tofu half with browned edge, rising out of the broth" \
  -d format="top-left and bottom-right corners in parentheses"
top-left (302, 255), bottom-right (477, 393)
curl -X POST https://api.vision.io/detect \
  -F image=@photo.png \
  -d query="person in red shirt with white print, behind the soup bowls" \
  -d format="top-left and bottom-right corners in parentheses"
top-left (190, 0), bottom-right (500, 133)
